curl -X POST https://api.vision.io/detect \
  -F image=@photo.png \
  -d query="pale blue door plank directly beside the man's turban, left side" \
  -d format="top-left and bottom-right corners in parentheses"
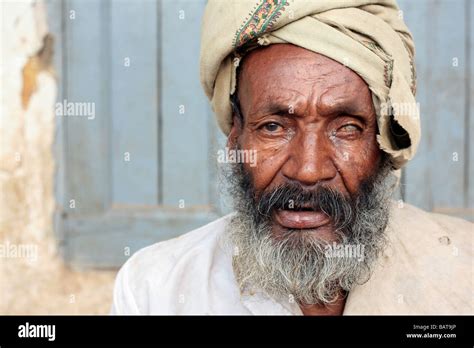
top-left (161, 0), bottom-right (213, 207)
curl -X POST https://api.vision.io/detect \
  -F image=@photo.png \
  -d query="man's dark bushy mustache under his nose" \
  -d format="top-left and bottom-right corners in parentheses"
top-left (254, 183), bottom-right (357, 229)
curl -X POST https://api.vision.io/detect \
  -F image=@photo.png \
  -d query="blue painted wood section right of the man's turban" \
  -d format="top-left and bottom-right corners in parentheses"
top-left (398, 0), bottom-right (474, 221)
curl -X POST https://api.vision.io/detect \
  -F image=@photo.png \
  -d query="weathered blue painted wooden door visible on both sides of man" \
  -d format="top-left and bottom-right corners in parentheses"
top-left (47, 0), bottom-right (474, 268)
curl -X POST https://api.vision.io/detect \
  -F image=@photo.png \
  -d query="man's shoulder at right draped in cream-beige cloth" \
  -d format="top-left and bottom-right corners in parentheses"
top-left (379, 204), bottom-right (474, 314)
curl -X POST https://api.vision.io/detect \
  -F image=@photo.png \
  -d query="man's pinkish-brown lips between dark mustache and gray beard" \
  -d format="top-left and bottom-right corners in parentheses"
top-left (275, 209), bottom-right (331, 229)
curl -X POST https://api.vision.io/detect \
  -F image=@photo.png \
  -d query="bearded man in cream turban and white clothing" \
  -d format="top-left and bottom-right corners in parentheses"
top-left (112, 0), bottom-right (473, 315)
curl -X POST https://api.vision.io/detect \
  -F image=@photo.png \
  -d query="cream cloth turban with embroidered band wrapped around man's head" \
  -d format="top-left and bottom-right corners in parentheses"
top-left (200, 0), bottom-right (420, 169)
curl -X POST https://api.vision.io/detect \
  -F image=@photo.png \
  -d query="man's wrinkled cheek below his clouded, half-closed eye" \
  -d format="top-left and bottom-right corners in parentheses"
top-left (334, 132), bottom-right (381, 193)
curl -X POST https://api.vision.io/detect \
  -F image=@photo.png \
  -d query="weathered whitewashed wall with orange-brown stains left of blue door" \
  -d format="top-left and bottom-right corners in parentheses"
top-left (0, 0), bottom-right (115, 314)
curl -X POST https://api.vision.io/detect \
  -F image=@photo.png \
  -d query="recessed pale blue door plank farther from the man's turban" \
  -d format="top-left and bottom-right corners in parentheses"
top-left (107, 0), bottom-right (160, 205)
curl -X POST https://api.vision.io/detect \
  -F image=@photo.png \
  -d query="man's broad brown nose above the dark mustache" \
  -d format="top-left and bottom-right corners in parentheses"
top-left (282, 132), bottom-right (337, 186)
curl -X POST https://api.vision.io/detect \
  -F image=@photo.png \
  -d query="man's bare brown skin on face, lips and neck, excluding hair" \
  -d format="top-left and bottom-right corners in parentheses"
top-left (228, 44), bottom-right (381, 315)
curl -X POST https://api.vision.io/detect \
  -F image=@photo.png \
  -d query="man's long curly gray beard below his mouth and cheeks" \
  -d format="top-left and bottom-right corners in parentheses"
top-left (224, 154), bottom-right (396, 305)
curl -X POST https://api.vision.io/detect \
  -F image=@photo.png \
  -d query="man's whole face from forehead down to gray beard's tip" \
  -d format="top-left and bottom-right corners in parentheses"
top-left (227, 44), bottom-right (393, 304)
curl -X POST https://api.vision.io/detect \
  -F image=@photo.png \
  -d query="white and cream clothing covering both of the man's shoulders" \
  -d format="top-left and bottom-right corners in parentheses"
top-left (111, 204), bottom-right (474, 315)
